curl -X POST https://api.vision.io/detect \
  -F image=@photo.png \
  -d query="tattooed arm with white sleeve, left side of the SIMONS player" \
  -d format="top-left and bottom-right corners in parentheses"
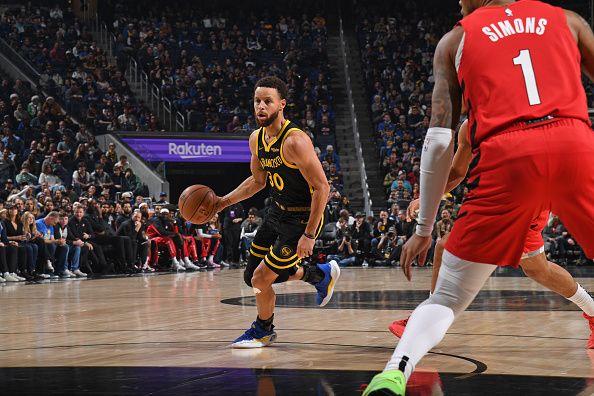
top-left (400, 26), bottom-right (464, 280)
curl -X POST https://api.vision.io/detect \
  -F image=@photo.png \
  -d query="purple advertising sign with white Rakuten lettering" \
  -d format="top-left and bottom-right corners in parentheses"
top-left (122, 138), bottom-right (251, 162)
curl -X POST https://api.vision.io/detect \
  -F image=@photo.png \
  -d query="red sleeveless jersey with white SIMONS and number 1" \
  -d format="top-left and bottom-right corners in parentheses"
top-left (456, 0), bottom-right (590, 148)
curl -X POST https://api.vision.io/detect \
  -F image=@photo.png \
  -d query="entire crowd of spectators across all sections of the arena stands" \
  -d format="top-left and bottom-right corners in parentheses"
top-left (0, 2), bottom-right (591, 282)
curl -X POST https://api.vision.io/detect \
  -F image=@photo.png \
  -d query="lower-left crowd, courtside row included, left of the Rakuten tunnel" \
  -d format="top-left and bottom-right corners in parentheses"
top-left (0, 73), bottom-right (234, 282)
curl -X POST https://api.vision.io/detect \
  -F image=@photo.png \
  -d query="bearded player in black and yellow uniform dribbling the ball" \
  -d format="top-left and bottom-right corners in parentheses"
top-left (217, 77), bottom-right (340, 348)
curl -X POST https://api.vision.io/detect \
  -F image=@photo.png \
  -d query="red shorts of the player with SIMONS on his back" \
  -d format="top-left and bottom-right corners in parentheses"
top-left (446, 119), bottom-right (594, 266)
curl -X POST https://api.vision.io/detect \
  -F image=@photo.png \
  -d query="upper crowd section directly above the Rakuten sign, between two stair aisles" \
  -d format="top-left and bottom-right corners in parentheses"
top-left (106, 1), bottom-right (335, 147)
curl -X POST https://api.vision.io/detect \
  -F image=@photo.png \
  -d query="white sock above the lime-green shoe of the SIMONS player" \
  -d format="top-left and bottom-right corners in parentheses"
top-left (384, 304), bottom-right (454, 381)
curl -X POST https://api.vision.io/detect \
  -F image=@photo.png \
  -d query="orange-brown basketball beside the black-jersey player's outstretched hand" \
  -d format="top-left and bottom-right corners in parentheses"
top-left (178, 184), bottom-right (217, 224)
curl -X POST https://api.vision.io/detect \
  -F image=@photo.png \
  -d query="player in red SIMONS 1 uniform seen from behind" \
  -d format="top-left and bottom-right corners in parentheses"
top-left (364, 0), bottom-right (594, 395)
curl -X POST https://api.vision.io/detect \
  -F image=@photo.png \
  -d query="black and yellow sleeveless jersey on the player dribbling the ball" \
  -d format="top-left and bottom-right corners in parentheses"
top-left (257, 120), bottom-right (312, 208)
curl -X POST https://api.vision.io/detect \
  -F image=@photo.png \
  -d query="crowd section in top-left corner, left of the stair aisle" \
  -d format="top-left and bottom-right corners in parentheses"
top-left (0, 3), bottom-right (163, 133)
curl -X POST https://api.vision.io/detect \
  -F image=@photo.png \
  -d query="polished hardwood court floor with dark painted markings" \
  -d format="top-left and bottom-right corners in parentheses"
top-left (0, 268), bottom-right (594, 395)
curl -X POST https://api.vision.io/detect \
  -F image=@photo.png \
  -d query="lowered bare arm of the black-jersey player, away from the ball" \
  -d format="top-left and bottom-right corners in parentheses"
top-left (283, 131), bottom-right (330, 257)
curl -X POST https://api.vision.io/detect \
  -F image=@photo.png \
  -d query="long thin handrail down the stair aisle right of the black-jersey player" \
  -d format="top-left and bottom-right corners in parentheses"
top-left (339, 10), bottom-right (373, 216)
